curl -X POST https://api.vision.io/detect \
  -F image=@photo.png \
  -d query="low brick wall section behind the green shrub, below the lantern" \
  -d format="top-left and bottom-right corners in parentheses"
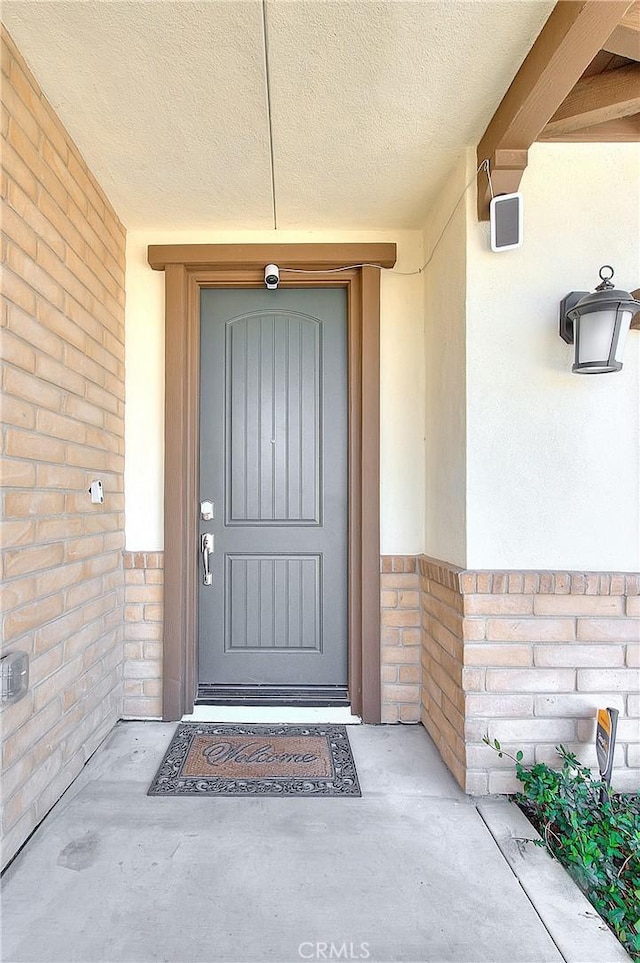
top-left (461, 572), bottom-right (640, 793)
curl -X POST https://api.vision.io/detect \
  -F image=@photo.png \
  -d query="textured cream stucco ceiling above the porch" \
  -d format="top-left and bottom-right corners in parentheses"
top-left (2, 0), bottom-right (554, 229)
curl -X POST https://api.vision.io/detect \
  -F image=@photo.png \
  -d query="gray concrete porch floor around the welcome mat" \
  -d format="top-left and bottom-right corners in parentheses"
top-left (2, 722), bottom-right (563, 963)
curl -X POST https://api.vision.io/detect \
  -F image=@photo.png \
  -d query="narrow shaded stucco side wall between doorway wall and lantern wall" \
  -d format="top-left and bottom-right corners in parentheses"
top-left (424, 158), bottom-right (470, 565)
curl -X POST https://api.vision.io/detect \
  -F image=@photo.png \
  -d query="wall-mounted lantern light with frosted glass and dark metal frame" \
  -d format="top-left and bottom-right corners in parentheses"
top-left (560, 264), bottom-right (640, 374)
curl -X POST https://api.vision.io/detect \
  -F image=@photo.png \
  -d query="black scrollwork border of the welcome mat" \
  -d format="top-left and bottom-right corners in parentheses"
top-left (147, 722), bottom-right (362, 798)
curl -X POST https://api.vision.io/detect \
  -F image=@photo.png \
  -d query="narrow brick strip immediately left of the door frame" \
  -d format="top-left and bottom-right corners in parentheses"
top-left (123, 552), bottom-right (164, 719)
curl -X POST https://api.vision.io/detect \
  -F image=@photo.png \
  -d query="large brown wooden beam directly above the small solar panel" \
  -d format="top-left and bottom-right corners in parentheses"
top-left (478, 0), bottom-right (632, 220)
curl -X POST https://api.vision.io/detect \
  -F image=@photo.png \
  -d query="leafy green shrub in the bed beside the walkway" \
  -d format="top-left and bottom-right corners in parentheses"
top-left (484, 736), bottom-right (640, 961)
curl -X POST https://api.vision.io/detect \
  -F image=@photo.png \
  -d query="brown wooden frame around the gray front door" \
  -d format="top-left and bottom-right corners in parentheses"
top-left (148, 244), bottom-right (396, 723)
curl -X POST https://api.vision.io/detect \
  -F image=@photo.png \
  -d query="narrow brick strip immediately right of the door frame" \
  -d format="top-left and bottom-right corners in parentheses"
top-left (380, 555), bottom-right (420, 722)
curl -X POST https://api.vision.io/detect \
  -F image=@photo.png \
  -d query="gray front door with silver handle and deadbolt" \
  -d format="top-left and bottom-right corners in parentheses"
top-left (200, 288), bottom-right (347, 691)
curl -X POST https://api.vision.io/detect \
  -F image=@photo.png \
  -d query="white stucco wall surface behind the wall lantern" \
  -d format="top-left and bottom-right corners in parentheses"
top-left (466, 144), bottom-right (640, 571)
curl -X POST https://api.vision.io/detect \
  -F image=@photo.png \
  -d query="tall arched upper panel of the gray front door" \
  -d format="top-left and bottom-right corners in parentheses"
top-left (225, 308), bottom-right (322, 525)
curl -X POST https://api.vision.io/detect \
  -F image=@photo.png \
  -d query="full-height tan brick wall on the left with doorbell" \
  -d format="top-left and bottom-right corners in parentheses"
top-left (1, 30), bottom-right (125, 863)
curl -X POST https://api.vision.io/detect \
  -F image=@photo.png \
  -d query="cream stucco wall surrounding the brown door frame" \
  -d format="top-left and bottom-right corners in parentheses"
top-left (125, 230), bottom-right (424, 554)
